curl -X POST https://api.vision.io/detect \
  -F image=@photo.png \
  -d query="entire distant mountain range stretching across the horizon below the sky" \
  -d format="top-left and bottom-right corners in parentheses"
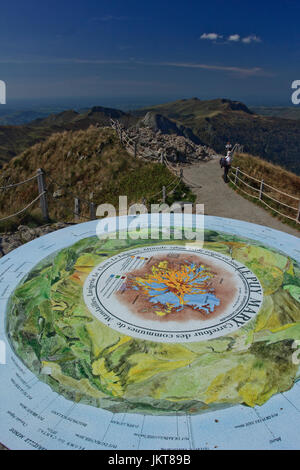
top-left (0, 98), bottom-right (300, 175)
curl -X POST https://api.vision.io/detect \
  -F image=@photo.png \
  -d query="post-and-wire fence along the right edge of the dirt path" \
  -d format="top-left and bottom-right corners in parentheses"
top-left (229, 167), bottom-right (300, 224)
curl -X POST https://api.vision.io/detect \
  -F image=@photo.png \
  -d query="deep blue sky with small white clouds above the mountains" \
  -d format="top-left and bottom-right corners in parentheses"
top-left (0, 0), bottom-right (300, 105)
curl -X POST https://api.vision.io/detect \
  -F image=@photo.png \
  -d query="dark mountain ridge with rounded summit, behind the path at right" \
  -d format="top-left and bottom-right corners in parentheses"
top-left (137, 98), bottom-right (300, 174)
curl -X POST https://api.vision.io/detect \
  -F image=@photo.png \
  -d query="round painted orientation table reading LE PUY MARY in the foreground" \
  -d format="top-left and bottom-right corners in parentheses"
top-left (0, 214), bottom-right (300, 450)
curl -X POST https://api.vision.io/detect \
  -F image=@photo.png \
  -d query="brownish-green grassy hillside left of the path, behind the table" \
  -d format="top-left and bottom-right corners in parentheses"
top-left (0, 126), bottom-right (191, 229)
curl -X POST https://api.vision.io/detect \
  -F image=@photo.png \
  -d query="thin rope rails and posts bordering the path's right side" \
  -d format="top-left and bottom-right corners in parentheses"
top-left (228, 166), bottom-right (300, 224)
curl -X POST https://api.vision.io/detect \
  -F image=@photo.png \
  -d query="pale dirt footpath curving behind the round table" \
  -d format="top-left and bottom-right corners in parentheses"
top-left (183, 159), bottom-right (300, 237)
